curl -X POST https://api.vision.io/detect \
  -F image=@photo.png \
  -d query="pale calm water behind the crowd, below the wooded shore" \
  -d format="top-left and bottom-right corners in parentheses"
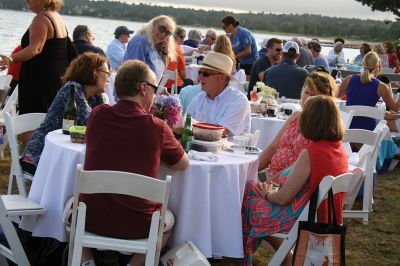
top-left (0, 9), bottom-right (358, 61)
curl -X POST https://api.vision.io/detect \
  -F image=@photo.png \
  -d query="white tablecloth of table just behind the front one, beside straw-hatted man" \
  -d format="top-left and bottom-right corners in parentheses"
top-left (251, 117), bottom-right (285, 150)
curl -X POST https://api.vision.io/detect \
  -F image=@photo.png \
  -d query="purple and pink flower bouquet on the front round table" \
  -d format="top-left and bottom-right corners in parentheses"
top-left (150, 95), bottom-right (182, 126)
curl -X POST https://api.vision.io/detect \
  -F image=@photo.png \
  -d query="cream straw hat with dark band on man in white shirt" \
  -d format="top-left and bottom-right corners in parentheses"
top-left (189, 51), bottom-right (239, 82)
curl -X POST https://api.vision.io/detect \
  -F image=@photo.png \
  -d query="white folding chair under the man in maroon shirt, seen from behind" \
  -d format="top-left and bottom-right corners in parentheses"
top-left (68, 165), bottom-right (171, 266)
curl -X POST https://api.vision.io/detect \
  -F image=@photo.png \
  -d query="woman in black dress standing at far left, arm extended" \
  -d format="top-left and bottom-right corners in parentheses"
top-left (0, 0), bottom-right (76, 142)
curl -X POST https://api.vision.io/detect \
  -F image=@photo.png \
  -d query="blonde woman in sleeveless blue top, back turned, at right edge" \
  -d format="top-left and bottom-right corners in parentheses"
top-left (339, 52), bottom-right (400, 130)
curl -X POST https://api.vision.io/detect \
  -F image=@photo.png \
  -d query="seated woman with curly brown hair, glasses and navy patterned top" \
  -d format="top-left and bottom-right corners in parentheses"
top-left (21, 52), bottom-right (110, 174)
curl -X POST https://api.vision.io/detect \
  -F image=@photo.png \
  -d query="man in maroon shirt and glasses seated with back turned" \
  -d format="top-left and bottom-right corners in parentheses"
top-left (80, 60), bottom-right (189, 265)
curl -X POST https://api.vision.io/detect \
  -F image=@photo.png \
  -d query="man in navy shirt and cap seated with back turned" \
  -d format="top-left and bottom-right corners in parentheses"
top-left (263, 41), bottom-right (308, 99)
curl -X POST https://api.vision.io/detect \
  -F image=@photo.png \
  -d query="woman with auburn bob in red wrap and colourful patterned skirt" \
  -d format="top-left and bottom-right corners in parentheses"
top-left (242, 95), bottom-right (348, 265)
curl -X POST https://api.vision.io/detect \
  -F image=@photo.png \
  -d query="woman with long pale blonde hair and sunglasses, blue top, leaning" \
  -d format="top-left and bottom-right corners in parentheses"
top-left (124, 15), bottom-right (177, 81)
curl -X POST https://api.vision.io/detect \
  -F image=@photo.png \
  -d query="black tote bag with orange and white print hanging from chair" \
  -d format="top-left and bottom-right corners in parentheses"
top-left (293, 186), bottom-right (346, 266)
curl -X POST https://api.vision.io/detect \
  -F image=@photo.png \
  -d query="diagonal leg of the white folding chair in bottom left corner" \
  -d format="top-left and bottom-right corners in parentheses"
top-left (0, 213), bottom-right (30, 266)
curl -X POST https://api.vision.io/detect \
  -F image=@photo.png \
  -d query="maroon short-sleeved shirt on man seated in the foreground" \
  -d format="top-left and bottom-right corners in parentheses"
top-left (80, 100), bottom-right (184, 239)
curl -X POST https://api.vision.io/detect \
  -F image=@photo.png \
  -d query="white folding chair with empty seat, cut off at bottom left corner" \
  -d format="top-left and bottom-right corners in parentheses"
top-left (0, 192), bottom-right (46, 266)
